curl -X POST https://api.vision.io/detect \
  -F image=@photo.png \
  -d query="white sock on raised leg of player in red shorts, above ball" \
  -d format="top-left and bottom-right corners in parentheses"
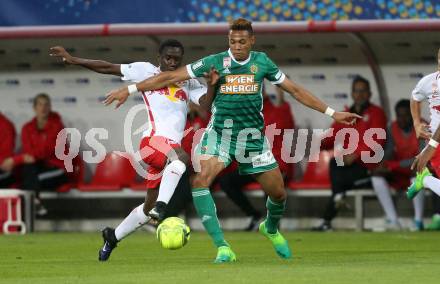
top-left (157, 160), bottom-right (186, 204)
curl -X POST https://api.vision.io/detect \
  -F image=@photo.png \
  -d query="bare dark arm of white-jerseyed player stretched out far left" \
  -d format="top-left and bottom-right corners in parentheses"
top-left (49, 46), bottom-right (122, 76)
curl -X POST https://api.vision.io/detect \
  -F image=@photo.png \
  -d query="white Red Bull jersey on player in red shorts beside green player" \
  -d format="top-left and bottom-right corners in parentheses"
top-left (121, 62), bottom-right (206, 144)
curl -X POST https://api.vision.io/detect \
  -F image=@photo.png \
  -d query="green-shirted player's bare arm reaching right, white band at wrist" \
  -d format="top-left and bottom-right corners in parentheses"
top-left (279, 78), bottom-right (362, 125)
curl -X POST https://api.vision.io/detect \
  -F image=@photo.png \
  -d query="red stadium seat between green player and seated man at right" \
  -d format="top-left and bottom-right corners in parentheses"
top-left (288, 151), bottom-right (333, 190)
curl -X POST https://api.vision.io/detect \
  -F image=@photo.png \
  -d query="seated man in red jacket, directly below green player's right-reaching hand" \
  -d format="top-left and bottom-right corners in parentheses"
top-left (313, 76), bottom-right (387, 231)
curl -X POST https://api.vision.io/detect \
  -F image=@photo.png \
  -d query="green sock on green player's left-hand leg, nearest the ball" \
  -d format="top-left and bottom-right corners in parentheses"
top-left (192, 188), bottom-right (229, 247)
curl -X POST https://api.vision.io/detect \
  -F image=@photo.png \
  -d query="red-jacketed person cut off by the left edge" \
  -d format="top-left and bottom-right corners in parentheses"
top-left (0, 113), bottom-right (17, 188)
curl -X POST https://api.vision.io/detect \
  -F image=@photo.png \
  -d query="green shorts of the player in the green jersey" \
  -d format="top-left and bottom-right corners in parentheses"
top-left (195, 128), bottom-right (278, 175)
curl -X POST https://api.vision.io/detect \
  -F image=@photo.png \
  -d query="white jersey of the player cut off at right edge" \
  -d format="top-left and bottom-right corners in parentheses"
top-left (412, 71), bottom-right (440, 133)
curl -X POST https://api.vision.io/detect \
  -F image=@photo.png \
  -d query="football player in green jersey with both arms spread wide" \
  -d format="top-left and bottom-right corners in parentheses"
top-left (104, 18), bottom-right (360, 263)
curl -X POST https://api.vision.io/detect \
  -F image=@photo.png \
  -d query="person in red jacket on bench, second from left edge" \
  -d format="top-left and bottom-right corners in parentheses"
top-left (21, 93), bottom-right (67, 215)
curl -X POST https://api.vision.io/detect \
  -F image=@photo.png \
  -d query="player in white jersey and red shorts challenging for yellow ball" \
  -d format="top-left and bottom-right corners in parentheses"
top-left (50, 39), bottom-right (218, 261)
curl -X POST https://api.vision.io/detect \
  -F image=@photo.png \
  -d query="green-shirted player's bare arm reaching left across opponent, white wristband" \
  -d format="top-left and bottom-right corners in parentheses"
top-left (104, 67), bottom-right (191, 108)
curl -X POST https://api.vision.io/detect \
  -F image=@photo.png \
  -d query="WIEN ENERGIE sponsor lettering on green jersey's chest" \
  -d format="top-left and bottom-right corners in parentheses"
top-left (220, 74), bottom-right (260, 95)
